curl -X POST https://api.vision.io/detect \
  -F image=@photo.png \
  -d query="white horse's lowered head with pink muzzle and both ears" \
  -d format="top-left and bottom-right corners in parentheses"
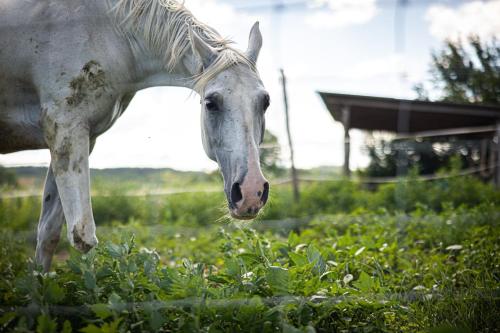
top-left (193, 23), bottom-right (270, 220)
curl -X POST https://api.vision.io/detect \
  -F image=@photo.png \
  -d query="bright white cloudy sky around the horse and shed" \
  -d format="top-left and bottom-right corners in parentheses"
top-left (0, 0), bottom-right (500, 170)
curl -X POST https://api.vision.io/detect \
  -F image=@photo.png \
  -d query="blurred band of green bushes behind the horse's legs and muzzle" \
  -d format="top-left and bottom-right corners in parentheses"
top-left (0, 171), bottom-right (500, 230)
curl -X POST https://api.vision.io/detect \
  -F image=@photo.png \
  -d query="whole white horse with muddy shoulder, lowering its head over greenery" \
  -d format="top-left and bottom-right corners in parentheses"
top-left (0, 0), bottom-right (269, 270)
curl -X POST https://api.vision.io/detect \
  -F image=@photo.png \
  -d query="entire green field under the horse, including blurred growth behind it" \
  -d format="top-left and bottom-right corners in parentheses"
top-left (0, 170), bottom-right (500, 333)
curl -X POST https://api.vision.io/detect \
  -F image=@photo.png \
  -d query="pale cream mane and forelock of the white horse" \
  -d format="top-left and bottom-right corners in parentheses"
top-left (111, 0), bottom-right (256, 91)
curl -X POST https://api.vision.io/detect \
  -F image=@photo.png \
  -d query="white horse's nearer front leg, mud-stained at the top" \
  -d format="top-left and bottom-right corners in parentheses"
top-left (45, 121), bottom-right (97, 252)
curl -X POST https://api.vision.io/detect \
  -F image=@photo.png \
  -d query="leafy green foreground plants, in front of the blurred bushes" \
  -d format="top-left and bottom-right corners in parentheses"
top-left (0, 205), bottom-right (500, 332)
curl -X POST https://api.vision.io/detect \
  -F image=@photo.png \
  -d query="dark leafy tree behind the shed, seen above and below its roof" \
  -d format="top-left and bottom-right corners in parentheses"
top-left (365, 37), bottom-right (500, 177)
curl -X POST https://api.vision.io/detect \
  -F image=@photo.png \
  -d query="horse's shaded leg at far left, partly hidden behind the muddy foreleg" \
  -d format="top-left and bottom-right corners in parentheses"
top-left (36, 166), bottom-right (64, 272)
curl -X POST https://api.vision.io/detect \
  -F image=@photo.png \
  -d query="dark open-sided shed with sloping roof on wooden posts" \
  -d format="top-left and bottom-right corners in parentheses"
top-left (319, 92), bottom-right (500, 179)
